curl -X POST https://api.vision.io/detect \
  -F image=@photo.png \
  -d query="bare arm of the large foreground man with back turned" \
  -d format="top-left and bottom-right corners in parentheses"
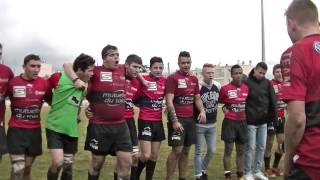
top-left (284, 100), bottom-right (306, 175)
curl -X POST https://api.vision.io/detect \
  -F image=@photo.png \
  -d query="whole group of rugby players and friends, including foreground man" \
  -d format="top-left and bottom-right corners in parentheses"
top-left (0, 0), bottom-right (320, 180)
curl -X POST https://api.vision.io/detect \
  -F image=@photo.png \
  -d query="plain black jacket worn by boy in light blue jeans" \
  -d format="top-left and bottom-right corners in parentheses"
top-left (246, 70), bottom-right (277, 125)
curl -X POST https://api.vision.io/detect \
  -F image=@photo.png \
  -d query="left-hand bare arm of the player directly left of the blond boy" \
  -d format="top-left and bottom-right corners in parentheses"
top-left (166, 93), bottom-right (183, 131)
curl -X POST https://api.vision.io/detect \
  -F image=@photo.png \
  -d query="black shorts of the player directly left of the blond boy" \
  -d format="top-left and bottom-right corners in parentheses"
top-left (167, 118), bottom-right (196, 147)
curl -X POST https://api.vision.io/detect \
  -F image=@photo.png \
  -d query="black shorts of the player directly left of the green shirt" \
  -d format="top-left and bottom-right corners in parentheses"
top-left (7, 127), bottom-right (42, 156)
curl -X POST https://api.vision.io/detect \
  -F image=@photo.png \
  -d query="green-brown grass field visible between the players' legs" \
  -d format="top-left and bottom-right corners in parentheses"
top-left (0, 108), bottom-right (280, 180)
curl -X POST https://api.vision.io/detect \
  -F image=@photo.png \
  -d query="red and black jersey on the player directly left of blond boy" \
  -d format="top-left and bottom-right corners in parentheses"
top-left (166, 71), bottom-right (200, 117)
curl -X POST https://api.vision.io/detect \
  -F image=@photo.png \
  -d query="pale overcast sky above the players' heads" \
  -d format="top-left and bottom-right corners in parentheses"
top-left (0, 0), bottom-right (320, 71)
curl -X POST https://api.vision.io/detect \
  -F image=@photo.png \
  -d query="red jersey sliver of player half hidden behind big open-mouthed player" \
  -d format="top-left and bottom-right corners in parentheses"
top-left (124, 77), bottom-right (140, 119)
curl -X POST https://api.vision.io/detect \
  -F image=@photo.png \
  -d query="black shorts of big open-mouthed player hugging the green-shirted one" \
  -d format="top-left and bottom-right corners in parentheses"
top-left (84, 122), bottom-right (132, 156)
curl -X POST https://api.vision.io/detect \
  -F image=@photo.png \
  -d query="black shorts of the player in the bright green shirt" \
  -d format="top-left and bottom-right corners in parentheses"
top-left (46, 129), bottom-right (78, 154)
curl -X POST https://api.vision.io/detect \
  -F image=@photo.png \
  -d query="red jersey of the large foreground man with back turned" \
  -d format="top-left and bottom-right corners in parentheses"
top-left (281, 34), bottom-right (320, 179)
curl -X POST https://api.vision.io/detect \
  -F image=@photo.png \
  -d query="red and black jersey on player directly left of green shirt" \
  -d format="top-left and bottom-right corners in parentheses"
top-left (8, 76), bottom-right (52, 128)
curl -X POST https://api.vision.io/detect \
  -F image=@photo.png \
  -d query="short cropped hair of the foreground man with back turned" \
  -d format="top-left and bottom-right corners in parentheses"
top-left (285, 0), bottom-right (319, 25)
